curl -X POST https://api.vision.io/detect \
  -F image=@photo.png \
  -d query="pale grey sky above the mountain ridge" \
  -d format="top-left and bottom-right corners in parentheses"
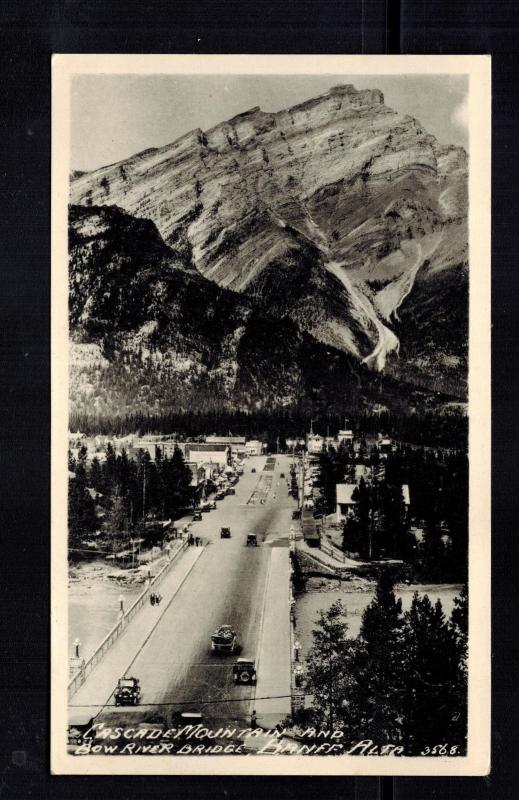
top-left (70, 74), bottom-right (468, 171)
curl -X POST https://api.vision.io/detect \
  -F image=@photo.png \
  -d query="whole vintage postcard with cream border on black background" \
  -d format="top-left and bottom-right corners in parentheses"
top-left (52, 55), bottom-right (490, 775)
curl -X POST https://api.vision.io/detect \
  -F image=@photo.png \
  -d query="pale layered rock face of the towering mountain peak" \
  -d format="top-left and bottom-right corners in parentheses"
top-left (70, 85), bottom-right (467, 394)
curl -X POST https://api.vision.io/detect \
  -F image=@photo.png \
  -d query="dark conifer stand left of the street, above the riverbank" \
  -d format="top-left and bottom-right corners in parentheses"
top-left (68, 444), bottom-right (193, 550)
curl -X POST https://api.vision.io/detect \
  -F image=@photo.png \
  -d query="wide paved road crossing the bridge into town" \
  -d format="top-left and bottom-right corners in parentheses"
top-left (88, 456), bottom-right (295, 726)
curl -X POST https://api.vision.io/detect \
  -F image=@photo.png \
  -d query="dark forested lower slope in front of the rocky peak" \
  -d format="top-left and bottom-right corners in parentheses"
top-left (69, 206), bottom-right (448, 420)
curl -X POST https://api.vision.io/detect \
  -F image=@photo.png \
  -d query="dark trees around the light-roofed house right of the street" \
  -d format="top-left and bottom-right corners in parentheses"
top-left (320, 445), bottom-right (468, 582)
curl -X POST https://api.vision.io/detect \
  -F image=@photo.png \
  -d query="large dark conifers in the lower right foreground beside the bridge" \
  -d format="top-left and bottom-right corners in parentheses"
top-left (301, 572), bottom-right (468, 756)
